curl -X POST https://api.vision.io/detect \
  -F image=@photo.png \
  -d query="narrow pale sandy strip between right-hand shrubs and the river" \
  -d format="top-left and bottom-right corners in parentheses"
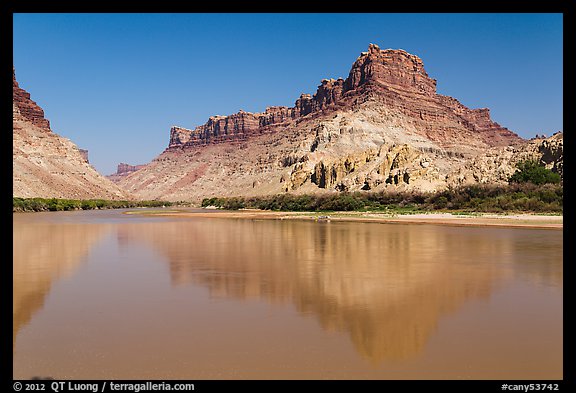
top-left (130, 209), bottom-right (564, 230)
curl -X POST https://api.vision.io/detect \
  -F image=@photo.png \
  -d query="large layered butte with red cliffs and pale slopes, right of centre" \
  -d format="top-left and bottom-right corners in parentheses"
top-left (119, 44), bottom-right (561, 200)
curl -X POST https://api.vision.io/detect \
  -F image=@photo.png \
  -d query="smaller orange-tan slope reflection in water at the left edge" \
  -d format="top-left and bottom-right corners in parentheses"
top-left (12, 220), bottom-right (109, 351)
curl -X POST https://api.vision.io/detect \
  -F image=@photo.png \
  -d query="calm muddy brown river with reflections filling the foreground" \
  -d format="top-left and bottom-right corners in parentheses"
top-left (12, 210), bottom-right (563, 380)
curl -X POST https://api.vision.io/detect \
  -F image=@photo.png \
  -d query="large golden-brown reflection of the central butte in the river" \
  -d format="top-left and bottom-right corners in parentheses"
top-left (119, 219), bottom-right (510, 363)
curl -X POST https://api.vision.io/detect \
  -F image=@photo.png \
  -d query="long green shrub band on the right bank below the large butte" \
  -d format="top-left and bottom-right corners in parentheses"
top-left (202, 182), bottom-right (564, 214)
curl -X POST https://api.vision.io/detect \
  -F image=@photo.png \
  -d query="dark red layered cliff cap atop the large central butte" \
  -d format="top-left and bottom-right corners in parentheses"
top-left (168, 44), bottom-right (522, 149)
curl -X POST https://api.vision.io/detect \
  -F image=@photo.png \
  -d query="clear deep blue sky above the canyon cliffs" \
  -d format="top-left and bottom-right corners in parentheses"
top-left (13, 14), bottom-right (563, 174)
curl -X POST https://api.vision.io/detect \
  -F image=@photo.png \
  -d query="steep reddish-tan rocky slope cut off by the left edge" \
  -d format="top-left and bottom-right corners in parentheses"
top-left (12, 69), bottom-right (132, 199)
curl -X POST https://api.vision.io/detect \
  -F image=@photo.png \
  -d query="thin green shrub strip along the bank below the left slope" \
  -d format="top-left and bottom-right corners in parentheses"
top-left (12, 197), bottom-right (171, 212)
